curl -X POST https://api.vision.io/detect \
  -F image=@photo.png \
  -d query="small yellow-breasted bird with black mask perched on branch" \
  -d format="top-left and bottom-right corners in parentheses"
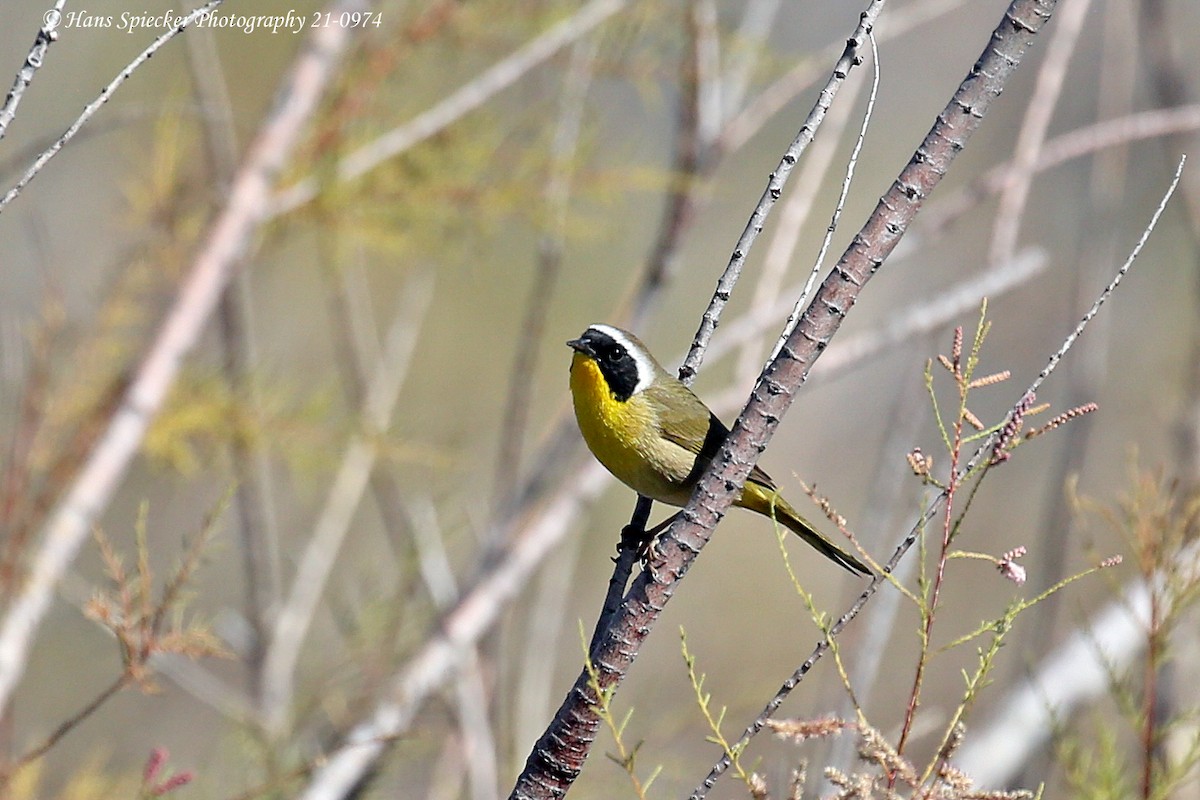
top-left (566, 325), bottom-right (870, 575)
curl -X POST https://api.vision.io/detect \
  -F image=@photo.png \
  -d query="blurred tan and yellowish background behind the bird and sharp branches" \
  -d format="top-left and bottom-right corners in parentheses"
top-left (0, 0), bottom-right (1200, 799)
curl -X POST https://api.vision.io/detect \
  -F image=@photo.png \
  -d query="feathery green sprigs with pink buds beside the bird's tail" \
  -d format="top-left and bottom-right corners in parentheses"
top-left (748, 303), bottom-right (1117, 800)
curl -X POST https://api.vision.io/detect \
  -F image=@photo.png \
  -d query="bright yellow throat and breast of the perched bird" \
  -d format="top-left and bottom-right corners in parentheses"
top-left (571, 353), bottom-right (690, 505)
